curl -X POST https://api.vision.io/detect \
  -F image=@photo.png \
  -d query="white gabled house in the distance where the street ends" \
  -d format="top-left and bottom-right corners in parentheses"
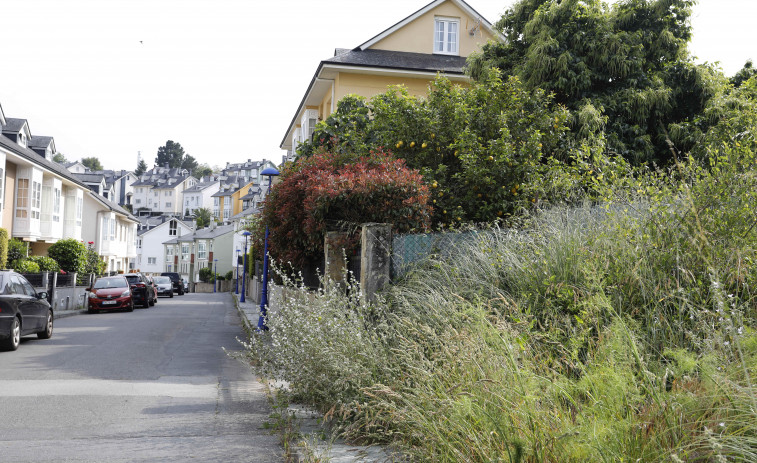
top-left (136, 216), bottom-right (194, 274)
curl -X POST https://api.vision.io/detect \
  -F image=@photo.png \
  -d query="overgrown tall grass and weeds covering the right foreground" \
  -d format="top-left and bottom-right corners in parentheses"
top-left (242, 150), bottom-right (757, 462)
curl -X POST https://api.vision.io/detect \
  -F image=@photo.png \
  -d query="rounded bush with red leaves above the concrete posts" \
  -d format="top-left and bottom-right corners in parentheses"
top-left (256, 150), bottom-right (431, 267)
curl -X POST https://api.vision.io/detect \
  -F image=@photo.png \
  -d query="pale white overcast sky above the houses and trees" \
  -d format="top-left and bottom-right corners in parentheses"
top-left (0, 0), bottom-right (757, 170)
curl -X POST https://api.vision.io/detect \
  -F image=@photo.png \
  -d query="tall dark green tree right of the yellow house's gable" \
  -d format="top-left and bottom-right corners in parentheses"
top-left (468, 0), bottom-right (723, 164)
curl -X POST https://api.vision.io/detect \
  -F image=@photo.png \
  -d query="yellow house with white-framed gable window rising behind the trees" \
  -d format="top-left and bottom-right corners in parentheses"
top-left (280, 0), bottom-right (504, 159)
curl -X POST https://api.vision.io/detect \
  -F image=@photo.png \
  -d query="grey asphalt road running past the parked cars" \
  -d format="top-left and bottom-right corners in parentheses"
top-left (0, 293), bottom-right (283, 462)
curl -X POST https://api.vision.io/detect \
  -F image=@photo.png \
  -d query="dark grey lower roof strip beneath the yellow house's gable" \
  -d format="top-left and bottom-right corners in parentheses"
top-left (321, 49), bottom-right (465, 74)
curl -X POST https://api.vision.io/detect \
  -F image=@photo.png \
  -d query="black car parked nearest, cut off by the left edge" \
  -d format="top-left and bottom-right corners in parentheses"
top-left (0, 270), bottom-right (53, 350)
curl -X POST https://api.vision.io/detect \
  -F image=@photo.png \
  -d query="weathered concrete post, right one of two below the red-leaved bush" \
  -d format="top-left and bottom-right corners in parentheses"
top-left (360, 223), bottom-right (392, 301)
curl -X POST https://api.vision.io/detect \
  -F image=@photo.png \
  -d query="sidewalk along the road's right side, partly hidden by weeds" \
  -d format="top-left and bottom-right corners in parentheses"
top-left (232, 292), bottom-right (397, 463)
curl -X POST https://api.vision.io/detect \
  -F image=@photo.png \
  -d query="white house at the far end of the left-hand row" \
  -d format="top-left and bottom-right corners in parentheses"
top-left (82, 191), bottom-right (139, 272)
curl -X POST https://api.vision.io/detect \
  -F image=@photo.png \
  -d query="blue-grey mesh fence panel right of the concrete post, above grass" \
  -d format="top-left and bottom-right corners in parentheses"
top-left (392, 230), bottom-right (492, 280)
